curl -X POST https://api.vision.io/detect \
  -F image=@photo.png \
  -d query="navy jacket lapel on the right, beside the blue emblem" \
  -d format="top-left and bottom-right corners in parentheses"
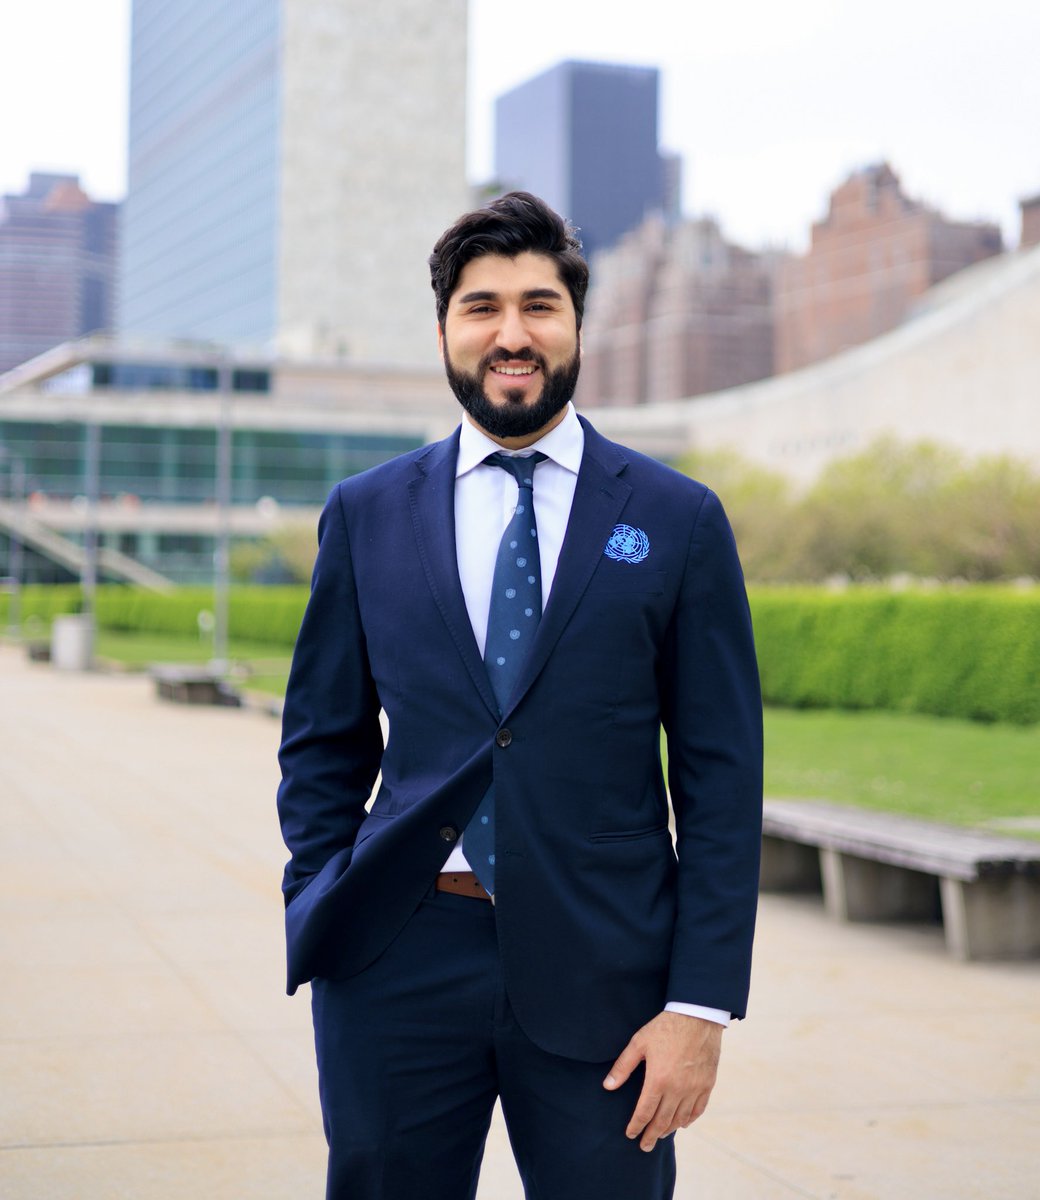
top-left (505, 418), bottom-right (632, 715)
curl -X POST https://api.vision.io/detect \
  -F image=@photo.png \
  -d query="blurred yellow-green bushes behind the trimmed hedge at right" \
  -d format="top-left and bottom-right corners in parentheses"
top-left (679, 438), bottom-right (1040, 583)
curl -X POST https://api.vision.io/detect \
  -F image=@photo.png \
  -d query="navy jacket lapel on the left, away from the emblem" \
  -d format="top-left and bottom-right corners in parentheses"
top-left (408, 430), bottom-right (498, 718)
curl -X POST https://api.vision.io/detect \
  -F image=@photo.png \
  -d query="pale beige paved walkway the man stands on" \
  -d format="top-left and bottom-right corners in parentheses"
top-left (0, 648), bottom-right (1040, 1200)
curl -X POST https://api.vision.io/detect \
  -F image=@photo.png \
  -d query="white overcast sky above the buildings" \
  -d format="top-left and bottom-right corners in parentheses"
top-left (0, 0), bottom-right (1040, 248)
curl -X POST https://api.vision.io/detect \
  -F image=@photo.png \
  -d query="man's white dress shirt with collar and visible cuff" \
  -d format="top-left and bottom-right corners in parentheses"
top-left (441, 404), bottom-right (729, 1025)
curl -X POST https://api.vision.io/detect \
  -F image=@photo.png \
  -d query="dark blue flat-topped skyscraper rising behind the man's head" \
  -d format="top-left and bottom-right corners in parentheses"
top-left (495, 62), bottom-right (678, 257)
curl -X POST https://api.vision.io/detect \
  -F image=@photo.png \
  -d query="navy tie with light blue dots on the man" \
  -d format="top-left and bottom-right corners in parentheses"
top-left (463, 451), bottom-right (546, 895)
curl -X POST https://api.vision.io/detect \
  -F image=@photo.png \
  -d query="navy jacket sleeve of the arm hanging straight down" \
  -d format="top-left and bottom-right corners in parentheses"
top-left (661, 492), bottom-right (762, 1018)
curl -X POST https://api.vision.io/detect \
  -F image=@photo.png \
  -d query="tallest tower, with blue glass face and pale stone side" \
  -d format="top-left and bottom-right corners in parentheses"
top-left (119, 0), bottom-right (468, 365)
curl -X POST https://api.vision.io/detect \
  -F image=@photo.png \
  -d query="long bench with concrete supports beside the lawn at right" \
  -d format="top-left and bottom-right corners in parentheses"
top-left (762, 800), bottom-right (1040, 959)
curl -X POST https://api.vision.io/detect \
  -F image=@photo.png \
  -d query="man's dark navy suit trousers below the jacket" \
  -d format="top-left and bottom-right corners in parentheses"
top-left (312, 889), bottom-right (675, 1200)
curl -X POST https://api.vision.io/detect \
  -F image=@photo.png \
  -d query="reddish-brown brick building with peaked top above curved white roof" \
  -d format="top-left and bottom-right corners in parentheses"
top-left (776, 163), bottom-right (1003, 372)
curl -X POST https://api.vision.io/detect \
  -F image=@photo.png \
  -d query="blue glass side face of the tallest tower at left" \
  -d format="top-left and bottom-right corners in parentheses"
top-left (120, 0), bottom-right (281, 342)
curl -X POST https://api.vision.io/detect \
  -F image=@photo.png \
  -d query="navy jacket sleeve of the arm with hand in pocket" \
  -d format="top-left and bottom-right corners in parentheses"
top-left (278, 485), bottom-right (383, 905)
